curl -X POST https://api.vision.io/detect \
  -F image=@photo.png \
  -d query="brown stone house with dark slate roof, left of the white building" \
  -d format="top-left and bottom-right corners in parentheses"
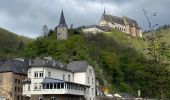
top-left (0, 60), bottom-right (27, 100)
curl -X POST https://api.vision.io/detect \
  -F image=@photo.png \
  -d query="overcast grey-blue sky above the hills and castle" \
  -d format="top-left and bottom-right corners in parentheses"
top-left (0, 0), bottom-right (170, 38)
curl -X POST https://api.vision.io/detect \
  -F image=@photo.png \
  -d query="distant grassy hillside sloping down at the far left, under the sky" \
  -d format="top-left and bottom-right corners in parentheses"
top-left (0, 28), bottom-right (32, 58)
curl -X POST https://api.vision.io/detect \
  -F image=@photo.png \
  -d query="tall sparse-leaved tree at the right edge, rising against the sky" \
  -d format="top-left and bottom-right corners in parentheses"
top-left (143, 10), bottom-right (170, 100)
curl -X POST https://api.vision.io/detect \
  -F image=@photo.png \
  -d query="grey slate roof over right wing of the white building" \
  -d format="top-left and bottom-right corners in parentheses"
top-left (68, 61), bottom-right (88, 72)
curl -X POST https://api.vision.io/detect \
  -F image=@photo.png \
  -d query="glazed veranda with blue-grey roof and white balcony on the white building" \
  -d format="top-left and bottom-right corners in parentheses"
top-left (23, 78), bottom-right (89, 96)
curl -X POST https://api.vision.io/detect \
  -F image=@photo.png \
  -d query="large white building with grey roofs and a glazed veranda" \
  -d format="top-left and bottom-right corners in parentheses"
top-left (23, 59), bottom-right (95, 100)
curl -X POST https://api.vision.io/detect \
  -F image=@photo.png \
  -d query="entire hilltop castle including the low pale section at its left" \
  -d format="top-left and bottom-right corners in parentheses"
top-left (82, 10), bottom-right (142, 37)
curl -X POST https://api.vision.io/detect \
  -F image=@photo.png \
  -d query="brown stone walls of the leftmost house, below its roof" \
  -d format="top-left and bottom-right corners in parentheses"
top-left (0, 72), bottom-right (26, 100)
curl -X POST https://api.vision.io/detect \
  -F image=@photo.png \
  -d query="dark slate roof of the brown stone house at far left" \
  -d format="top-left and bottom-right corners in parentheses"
top-left (0, 60), bottom-right (28, 74)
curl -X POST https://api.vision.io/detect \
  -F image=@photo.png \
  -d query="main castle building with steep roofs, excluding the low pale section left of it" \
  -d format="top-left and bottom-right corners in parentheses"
top-left (99, 11), bottom-right (142, 37)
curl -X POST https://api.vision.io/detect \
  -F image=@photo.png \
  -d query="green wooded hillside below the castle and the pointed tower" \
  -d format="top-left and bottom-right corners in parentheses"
top-left (24, 29), bottom-right (170, 96)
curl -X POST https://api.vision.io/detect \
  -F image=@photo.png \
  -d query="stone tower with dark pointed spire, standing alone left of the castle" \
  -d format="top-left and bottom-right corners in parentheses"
top-left (57, 10), bottom-right (68, 40)
